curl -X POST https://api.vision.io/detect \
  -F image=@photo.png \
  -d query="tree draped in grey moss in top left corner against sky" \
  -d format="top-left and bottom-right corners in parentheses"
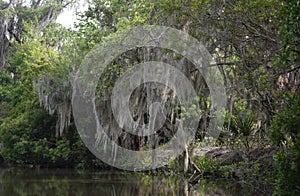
top-left (0, 0), bottom-right (73, 69)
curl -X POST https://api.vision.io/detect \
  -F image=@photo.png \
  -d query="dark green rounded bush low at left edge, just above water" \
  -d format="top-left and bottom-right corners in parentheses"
top-left (0, 100), bottom-right (64, 165)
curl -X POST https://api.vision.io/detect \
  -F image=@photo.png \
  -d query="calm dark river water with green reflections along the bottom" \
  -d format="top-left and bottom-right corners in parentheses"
top-left (0, 169), bottom-right (268, 196)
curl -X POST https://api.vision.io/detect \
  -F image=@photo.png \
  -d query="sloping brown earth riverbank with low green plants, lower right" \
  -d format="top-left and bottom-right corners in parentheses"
top-left (190, 147), bottom-right (279, 194)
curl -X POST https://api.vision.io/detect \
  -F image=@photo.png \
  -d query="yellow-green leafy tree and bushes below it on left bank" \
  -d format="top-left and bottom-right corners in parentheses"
top-left (0, 22), bottom-right (76, 165)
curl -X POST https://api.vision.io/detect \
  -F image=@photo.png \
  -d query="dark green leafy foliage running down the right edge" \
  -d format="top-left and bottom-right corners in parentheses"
top-left (270, 0), bottom-right (300, 195)
